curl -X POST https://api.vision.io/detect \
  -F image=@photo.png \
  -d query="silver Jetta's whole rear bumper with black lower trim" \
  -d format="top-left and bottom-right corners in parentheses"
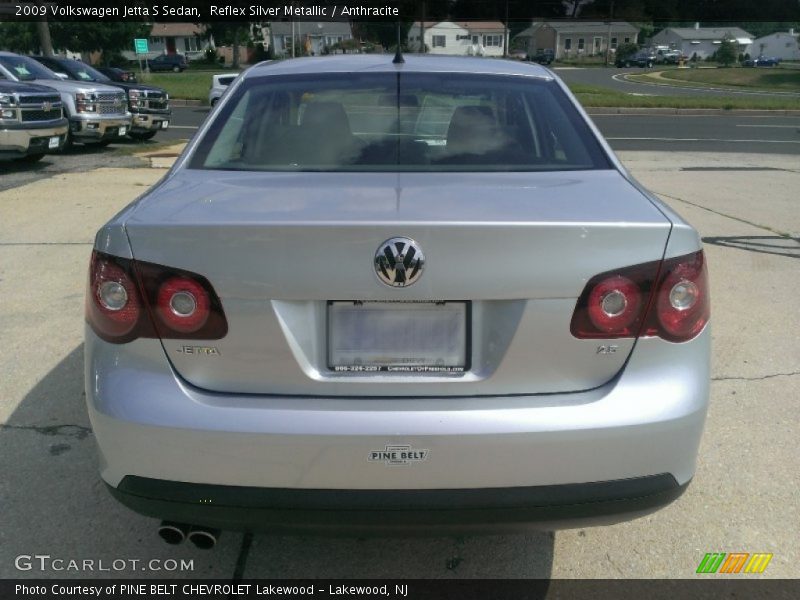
top-left (85, 327), bottom-right (711, 530)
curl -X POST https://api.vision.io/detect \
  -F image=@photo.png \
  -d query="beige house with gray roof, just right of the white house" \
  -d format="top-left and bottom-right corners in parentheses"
top-left (512, 20), bottom-right (639, 60)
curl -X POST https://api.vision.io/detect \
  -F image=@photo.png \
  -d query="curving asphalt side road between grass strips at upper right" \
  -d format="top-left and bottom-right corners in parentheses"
top-left (554, 67), bottom-right (800, 98)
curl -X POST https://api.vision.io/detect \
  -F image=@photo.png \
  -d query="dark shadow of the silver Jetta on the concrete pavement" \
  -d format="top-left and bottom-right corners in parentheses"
top-left (0, 345), bottom-right (555, 579)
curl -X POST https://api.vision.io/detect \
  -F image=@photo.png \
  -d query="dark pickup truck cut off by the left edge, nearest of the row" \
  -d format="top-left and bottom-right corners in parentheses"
top-left (0, 80), bottom-right (68, 162)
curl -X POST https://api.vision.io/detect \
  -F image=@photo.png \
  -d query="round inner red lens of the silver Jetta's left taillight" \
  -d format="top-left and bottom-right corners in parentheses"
top-left (156, 277), bottom-right (211, 333)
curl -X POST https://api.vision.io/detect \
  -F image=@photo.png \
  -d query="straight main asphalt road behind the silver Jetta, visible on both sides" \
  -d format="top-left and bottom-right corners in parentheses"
top-left (155, 107), bottom-right (800, 154)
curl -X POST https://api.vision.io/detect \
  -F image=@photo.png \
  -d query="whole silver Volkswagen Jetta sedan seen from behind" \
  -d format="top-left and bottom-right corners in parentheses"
top-left (86, 55), bottom-right (710, 541)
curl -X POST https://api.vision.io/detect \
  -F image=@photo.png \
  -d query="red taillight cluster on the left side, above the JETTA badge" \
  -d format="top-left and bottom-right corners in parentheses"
top-left (86, 251), bottom-right (228, 344)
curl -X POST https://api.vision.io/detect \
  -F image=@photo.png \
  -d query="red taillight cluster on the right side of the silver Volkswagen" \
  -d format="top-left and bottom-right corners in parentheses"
top-left (570, 250), bottom-right (710, 342)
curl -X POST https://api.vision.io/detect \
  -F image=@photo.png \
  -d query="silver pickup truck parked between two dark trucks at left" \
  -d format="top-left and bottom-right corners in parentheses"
top-left (0, 52), bottom-right (131, 146)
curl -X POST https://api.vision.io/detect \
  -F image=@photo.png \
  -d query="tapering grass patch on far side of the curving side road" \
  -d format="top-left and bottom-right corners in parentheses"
top-left (632, 67), bottom-right (800, 92)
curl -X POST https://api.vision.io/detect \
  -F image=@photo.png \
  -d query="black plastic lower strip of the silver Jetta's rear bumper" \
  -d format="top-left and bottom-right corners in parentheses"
top-left (109, 474), bottom-right (689, 534)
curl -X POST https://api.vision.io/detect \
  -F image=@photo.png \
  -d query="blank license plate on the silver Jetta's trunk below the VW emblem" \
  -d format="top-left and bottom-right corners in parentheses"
top-left (328, 302), bottom-right (468, 373)
